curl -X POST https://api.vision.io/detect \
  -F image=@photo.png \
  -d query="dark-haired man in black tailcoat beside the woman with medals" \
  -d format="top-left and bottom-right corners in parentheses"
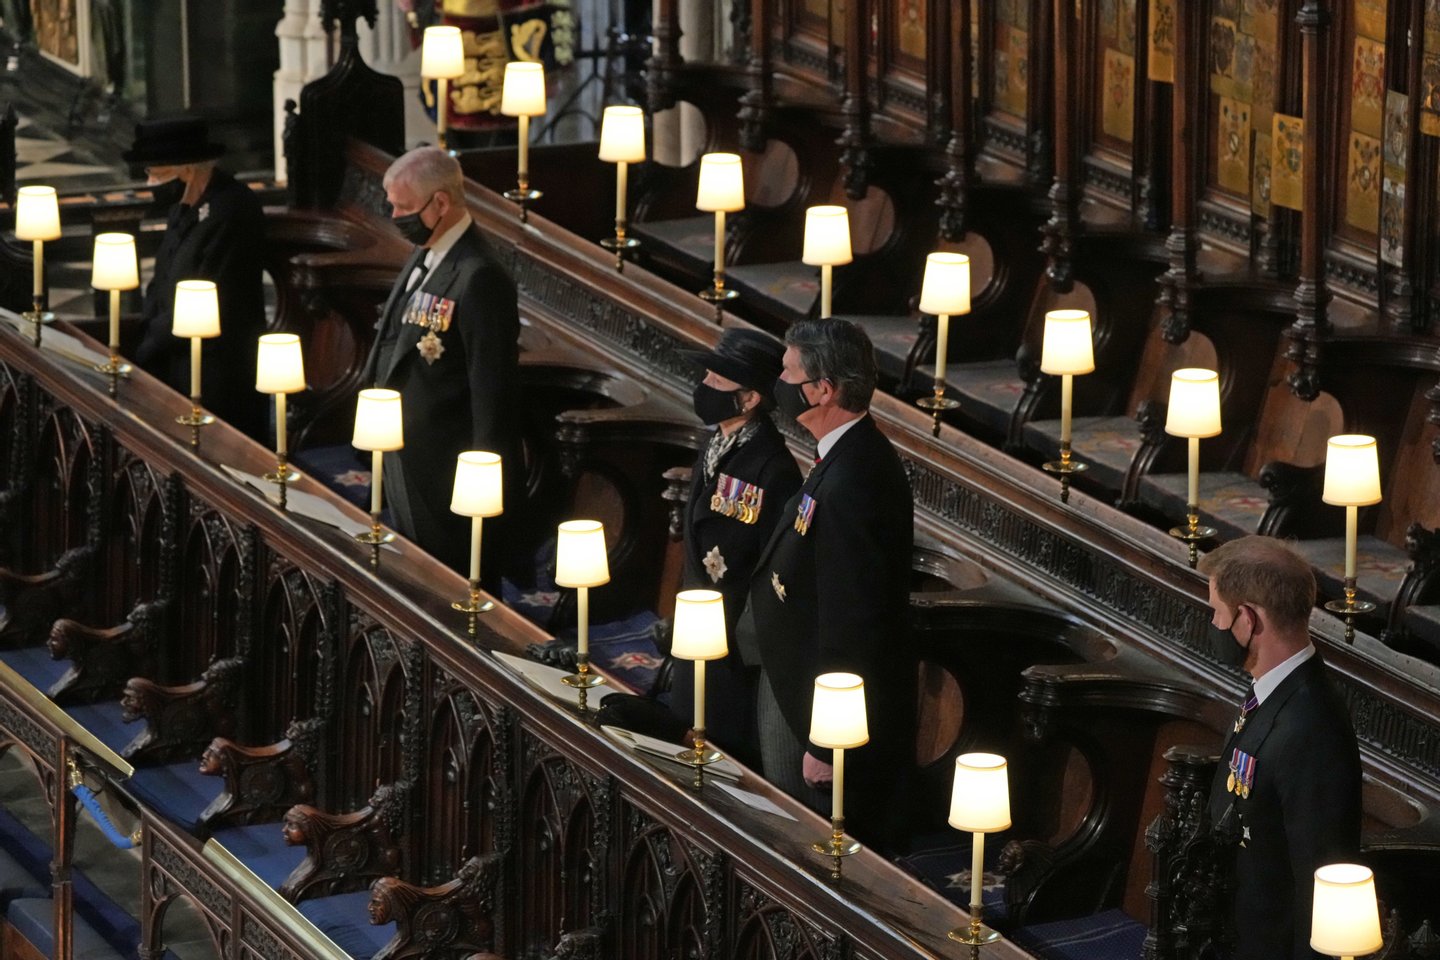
top-left (750, 320), bottom-right (916, 846)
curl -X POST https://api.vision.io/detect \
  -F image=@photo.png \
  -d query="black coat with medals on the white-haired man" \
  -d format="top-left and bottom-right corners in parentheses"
top-left (361, 225), bottom-right (524, 584)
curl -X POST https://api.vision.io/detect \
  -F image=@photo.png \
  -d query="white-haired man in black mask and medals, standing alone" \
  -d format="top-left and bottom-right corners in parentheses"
top-left (363, 147), bottom-right (524, 581)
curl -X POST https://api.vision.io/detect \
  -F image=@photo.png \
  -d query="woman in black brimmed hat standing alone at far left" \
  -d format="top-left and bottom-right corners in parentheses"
top-left (125, 117), bottom-right (268, 442)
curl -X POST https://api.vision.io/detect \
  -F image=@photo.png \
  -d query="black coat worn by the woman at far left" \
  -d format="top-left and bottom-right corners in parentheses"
top-left (135, 170), bottom-right (269, 443)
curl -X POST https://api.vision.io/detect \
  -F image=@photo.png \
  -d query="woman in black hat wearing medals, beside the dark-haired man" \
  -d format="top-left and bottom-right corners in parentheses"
top-left (670, 328), bottom-right (801, 767)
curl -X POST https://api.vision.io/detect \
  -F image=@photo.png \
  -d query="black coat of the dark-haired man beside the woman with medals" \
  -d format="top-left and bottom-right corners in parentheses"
top-left (750, 416), bottom-right (916, 838)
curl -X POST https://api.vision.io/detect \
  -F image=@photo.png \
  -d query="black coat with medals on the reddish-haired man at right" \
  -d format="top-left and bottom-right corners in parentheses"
top-left (1210, 655), bottom-right (1361, 960)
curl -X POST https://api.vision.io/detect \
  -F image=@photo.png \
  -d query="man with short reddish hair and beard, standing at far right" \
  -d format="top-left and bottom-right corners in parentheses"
top-left (1200, 537), bottom-right (1361, 960)
